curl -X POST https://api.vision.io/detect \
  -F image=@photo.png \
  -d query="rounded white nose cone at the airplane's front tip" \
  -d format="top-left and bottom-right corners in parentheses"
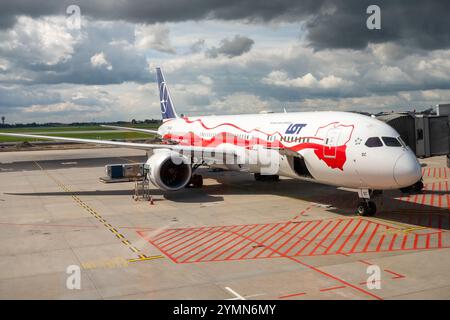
top-left (394, 152), bottom-right (422, 188)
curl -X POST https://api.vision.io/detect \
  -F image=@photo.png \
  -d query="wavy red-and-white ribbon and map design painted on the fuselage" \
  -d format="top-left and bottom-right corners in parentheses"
top-left (163, 118), bottom-right (354, 171)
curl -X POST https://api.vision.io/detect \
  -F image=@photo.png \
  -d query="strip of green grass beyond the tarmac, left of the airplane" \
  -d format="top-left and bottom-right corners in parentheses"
top-left (0, 131), bottom-right (154, 142)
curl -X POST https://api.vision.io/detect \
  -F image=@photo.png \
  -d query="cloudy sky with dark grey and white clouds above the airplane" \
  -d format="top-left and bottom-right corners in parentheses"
top-left (0, 0), bottom-right (450, 123)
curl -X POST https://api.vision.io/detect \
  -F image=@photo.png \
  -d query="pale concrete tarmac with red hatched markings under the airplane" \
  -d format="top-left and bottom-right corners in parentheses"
top-left (0, 148), bottom-right (450, 300)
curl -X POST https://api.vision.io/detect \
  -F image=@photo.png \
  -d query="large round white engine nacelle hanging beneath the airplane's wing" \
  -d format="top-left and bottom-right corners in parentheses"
top-left (146, 151), bottom-right (192, 191)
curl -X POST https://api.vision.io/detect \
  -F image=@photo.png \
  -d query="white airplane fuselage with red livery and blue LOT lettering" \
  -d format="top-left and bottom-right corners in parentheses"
top-left (158, 111), bottom-right (421, 190)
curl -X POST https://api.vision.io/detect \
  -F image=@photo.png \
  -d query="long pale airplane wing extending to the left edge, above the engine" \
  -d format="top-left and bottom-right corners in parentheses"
top-left (0, 132), bottom-right (235, 158)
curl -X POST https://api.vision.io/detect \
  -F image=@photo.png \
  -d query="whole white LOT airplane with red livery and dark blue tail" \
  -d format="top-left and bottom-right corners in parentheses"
top-left (0, 67), bottom-right (423, 216)
